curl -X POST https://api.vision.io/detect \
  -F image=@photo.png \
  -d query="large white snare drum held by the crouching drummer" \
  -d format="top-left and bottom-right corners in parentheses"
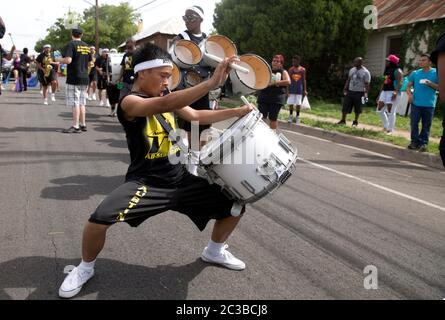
top-left (199, 110), bottom-right (297, 204)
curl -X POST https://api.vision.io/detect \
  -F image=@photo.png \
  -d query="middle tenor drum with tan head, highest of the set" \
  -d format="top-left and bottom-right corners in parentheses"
top-left (199, 35), bottom-right (238, 68)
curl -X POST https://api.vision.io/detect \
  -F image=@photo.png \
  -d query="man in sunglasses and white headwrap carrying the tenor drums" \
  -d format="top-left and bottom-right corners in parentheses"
top-left (173, 6), bottom-right (211, 145)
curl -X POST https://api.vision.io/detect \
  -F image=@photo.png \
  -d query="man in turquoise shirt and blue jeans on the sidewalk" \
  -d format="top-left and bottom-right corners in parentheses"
top-left (406, 54), bottom-right (439, 152)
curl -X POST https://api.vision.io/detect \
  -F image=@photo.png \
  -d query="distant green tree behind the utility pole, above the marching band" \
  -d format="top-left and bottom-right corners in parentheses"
top-left (34, 2), bottom-right (139, 52)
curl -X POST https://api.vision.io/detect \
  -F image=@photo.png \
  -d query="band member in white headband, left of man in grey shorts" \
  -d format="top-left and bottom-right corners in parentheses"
top-left (36, 44), bottom-right (57, 105)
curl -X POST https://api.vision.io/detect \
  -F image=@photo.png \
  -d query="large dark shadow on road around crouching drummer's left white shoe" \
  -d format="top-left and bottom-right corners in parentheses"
top-left (0, 257), bottom-right (209, 300)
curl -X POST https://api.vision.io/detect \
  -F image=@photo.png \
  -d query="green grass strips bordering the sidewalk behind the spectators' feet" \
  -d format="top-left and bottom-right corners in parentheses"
top-left (220, 96), bottom-right (442, 155)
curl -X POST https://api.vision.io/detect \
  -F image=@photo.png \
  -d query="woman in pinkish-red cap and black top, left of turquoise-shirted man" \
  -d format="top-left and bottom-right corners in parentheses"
top-left (377, 54), bottom-right (403, 134)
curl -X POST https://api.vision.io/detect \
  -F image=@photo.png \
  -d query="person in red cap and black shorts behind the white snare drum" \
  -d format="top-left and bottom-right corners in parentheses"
top-left (257, 54), bottom-right (290, 130)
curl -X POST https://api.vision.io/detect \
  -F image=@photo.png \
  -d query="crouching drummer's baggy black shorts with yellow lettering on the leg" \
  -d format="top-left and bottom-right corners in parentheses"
top-left (89, 172), bottom-right (245, 231)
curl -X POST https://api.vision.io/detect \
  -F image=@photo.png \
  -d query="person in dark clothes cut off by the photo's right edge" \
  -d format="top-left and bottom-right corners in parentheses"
top-left (431, 33), bottom-right (445, 168)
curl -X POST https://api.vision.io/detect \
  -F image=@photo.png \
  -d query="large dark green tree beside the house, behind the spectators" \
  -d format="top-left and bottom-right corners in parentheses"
top-left (214, 0), bottom-right (372, 99)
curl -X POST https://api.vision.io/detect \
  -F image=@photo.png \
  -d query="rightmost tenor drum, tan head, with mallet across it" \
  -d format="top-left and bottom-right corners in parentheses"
top-left (230, 54), bottom-right (272, 95)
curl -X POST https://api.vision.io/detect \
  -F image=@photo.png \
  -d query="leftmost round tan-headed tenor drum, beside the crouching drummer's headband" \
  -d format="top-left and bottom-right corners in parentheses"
top-left (169, 39), bottom-right (202, 69)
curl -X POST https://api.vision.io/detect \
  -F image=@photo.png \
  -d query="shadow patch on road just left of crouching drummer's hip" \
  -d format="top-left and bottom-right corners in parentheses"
top-left (40, 175), bottom-right (124, 200)
